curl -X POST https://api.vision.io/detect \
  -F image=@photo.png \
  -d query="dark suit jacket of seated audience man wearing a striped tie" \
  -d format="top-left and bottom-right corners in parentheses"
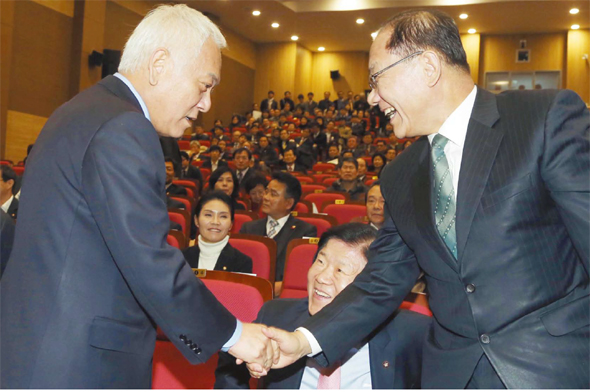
top-left (240, 215), bottom-right (318, 281)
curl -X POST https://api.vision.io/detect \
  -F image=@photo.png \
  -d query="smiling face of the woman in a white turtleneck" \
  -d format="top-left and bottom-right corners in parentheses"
top-left (200, 199), bottom-right (232, 243)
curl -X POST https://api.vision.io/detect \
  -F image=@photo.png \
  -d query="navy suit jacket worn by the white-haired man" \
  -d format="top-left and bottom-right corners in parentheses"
top-left (0, 76), bottom-right (236, 389)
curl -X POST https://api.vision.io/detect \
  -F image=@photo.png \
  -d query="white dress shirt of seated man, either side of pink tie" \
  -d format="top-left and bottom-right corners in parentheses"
top-left (299, 343), bottom-right (372, 389)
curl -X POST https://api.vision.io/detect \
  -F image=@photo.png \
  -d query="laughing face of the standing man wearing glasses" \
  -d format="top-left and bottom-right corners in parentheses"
top-left (368, 29), bottom-right (438, 138)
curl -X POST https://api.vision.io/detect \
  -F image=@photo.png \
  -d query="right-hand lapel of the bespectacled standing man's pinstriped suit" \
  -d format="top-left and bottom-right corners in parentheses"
top-left (456, 88), bottom-right (504, 263)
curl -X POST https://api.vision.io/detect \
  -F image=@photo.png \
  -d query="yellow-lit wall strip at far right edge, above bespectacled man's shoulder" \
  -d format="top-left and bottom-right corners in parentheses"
top-left (566, 30), bottom-right (590, 105)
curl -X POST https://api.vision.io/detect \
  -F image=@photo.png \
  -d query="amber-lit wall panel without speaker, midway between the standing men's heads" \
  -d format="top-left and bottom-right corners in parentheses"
top-left (252, 43), bottom-right (297, 103)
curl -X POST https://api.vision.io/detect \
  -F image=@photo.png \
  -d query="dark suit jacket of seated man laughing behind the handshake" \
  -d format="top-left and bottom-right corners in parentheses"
top-left (215, 298), bottom-right (431, 389)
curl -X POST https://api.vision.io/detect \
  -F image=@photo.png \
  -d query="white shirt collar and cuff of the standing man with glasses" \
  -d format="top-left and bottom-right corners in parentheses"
top-left (296, 86), bottom-right (477, 357)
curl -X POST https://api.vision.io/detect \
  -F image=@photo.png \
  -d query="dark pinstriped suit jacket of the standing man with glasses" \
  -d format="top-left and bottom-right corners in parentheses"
top-left (304, 89), bottom-right (590, 389)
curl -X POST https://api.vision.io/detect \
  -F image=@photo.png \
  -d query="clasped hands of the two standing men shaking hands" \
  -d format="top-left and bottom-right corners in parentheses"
top-left (229, 323), bottom-right (311, 378)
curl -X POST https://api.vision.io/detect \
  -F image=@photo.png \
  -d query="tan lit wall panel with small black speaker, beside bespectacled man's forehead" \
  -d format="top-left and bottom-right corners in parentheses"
top-left (311, 52), bottom-right (369, 100)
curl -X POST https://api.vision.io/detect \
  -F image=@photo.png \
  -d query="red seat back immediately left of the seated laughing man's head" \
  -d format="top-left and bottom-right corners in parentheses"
top-left (280, 239), bottom-right (318, 298)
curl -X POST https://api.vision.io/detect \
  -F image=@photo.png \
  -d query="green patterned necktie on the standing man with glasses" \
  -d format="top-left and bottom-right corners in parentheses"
top-left (431, 134), bottom-right (457, 260)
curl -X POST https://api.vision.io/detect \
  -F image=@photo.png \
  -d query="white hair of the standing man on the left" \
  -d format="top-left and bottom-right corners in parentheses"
top-left (119, 4), bottom-right (227, 73)
